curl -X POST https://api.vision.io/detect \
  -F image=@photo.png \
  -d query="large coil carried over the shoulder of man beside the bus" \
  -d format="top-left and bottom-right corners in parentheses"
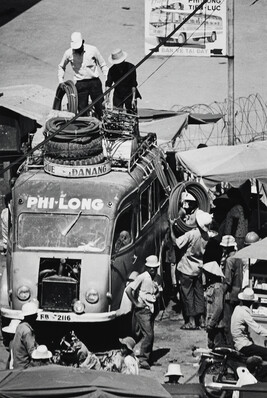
top-left (168, 181), bottom-right (210, 235)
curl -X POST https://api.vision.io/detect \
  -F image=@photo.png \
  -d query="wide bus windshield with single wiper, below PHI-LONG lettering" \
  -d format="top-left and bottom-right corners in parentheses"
top-left (18, 213), bottom-right (108, 252)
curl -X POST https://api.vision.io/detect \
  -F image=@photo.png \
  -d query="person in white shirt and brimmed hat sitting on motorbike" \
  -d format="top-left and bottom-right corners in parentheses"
top-left (231, 287), bottom-right (267, 361)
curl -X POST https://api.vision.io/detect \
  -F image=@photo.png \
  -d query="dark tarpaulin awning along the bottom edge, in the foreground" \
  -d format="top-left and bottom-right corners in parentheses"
top-left (0, 365), bottom-right (171, 398)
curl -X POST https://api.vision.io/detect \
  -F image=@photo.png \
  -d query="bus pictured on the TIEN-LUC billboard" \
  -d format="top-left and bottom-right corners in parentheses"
top-left (149, 8), bottom-right (223, 46)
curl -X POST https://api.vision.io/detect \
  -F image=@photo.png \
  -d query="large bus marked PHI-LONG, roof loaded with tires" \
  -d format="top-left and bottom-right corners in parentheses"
top-left (0, 112), bottom-right (176, 341)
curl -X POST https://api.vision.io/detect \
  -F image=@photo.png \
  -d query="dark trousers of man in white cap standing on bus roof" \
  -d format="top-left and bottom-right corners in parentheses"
top-left (76, 77), bottom-right (103, 119)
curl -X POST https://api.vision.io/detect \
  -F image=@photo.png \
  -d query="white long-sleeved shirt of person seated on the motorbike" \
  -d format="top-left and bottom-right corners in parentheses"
top-left (231, 305), bottom-right (267, 351)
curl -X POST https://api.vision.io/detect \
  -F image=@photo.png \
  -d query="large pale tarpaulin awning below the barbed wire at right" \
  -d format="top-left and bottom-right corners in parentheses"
top-left (176, 141), bottom-right (267, 188)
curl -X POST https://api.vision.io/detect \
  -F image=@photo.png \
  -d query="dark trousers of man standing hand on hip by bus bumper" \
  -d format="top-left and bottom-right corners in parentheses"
top-left (134, 308), bottom-right (155, 362)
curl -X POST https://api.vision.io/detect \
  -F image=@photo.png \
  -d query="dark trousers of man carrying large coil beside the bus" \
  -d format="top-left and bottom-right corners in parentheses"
top-left (179, 272), bottom-right (205, 318)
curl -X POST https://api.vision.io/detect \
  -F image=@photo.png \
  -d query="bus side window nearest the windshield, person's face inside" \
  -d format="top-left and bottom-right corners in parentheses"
top-left (114, 205), bottom-right (136, 252)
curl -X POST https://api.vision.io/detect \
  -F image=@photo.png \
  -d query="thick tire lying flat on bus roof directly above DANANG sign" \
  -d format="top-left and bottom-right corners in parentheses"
top-left (45, 137), bottom-right (102, 159)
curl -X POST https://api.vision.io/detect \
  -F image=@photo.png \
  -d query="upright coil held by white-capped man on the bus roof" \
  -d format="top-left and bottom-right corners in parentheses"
top-left (53, 80), bottom-right (78, 114)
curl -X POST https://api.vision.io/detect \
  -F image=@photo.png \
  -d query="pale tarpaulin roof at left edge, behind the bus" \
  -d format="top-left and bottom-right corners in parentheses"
top-left (0, 84), bottom-right (55, 126)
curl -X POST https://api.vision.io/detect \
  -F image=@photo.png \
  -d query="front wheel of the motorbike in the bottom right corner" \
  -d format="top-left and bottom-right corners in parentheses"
top-left (199, 362), bottom-right (238, 398)
